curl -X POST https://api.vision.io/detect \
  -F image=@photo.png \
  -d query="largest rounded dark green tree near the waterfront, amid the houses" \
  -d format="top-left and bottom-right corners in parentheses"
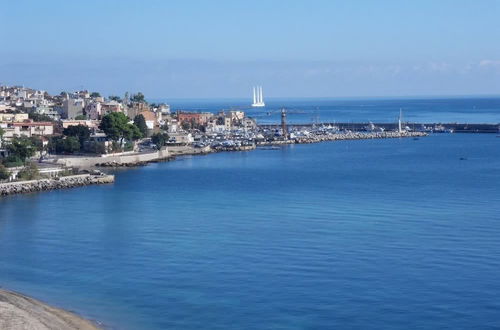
top-left (99, 112), bottom-right (142, 145)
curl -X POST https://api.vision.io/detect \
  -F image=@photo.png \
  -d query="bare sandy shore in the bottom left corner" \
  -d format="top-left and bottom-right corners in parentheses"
top-left (0, 289), bottom-right (100, 330)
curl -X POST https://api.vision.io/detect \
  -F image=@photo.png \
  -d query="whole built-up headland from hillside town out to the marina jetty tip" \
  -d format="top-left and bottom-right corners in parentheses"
top-left (0, 86), bottom-right (426, 188)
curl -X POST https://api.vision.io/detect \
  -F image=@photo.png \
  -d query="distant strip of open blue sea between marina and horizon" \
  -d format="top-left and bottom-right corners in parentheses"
top-left (159, 97), bottom-right (500, 124)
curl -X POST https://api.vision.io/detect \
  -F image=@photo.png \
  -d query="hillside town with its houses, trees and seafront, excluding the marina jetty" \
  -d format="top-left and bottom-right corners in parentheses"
top-left (0, 86), bottom-right (264, 181)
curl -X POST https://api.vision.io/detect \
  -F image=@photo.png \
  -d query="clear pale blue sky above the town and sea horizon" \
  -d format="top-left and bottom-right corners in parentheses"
top-left (0, 0), bottom-right (500, 99)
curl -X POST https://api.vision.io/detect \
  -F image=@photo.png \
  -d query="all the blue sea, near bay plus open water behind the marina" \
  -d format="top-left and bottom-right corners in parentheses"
top-left (0, 98), bottom-right (500, 330)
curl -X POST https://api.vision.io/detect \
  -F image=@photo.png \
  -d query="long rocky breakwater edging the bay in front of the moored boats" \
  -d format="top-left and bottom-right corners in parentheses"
top-left (258, 132), bottom-right (427, 146)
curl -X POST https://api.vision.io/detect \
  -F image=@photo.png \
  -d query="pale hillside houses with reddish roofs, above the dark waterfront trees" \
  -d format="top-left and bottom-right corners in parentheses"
top-left (0, 86), bottom-right (256, 150)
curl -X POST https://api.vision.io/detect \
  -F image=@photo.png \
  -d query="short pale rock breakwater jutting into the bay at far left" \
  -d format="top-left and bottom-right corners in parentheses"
top-left (0, 174), bottom-right (115, 196)
